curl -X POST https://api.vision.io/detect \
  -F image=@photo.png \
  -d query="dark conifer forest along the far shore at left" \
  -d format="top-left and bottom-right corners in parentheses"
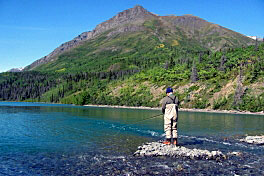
top-left (0, 69), bottom-right (139, 103)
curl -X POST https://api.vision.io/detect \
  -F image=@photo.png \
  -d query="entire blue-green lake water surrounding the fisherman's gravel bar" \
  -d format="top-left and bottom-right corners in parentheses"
top-left (0, 102), bottom-right (264, 175)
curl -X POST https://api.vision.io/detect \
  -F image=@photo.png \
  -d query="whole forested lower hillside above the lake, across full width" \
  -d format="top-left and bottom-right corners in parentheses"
top-left (0, 41), bottom-right (264, 111)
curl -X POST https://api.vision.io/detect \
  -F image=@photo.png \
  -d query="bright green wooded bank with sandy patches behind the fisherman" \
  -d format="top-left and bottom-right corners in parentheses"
top-left (58, 45), bottom-right (264, 111)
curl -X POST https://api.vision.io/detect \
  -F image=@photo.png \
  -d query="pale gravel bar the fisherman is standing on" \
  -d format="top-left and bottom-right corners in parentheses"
top-left (134, 142), bottom-right (226, 160)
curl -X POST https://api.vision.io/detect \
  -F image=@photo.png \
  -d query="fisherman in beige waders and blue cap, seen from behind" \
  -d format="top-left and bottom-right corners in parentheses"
top-left (162, 87), bottom-right (179, 145)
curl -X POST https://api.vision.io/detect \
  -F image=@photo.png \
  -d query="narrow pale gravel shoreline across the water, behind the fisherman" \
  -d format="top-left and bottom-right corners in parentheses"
top-left (83, 104), bottom-right (264, 115)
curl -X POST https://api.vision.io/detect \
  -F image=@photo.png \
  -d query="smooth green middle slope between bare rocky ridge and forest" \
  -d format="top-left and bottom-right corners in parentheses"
top-left (34, 21), bottom-right (207, 73)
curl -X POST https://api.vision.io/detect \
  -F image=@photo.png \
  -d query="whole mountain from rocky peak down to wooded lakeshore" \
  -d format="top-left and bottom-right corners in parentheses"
top-left (0, 6), bottom-right (264, 112)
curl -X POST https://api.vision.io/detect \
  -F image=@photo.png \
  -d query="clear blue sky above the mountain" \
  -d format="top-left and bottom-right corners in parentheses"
top-left (0, 0), bottom-right (264, 72)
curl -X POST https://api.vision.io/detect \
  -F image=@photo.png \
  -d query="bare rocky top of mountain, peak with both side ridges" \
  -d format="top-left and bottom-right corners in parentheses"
top-left (24, 6), bottom-right (254, 71)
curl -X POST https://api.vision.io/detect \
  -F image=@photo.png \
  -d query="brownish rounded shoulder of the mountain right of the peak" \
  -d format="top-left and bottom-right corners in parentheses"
top-left (163, 15), bottom-right (253, 50)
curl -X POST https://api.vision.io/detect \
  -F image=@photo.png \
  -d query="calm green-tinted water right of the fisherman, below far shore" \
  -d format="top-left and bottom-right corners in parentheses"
top-left (179, 112), bottom-right (264, 136)
